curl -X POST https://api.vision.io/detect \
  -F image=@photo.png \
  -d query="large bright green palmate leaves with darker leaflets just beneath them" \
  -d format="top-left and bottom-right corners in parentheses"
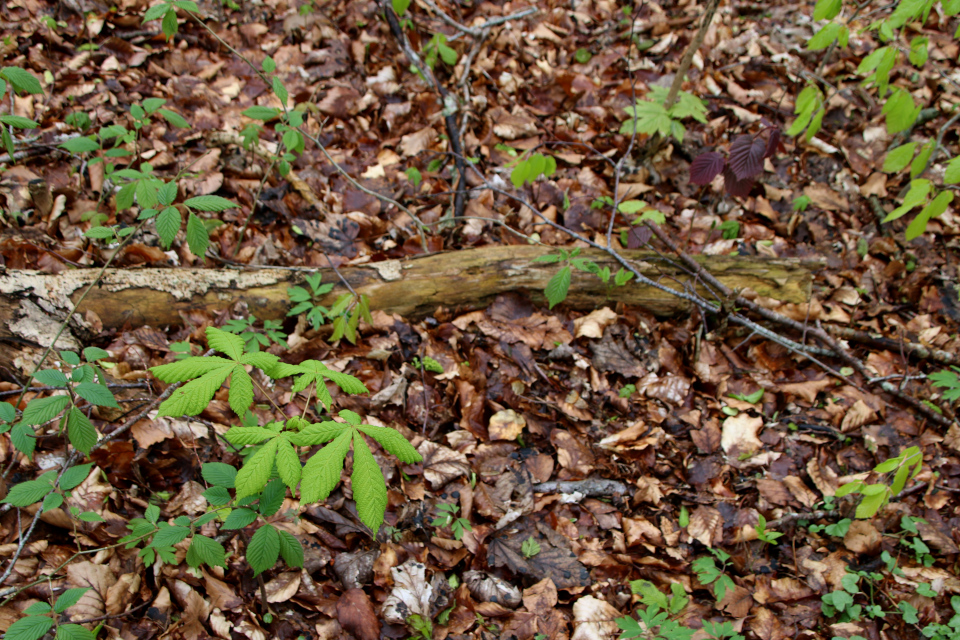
top-left (123, 327), bottom-right (422, 574)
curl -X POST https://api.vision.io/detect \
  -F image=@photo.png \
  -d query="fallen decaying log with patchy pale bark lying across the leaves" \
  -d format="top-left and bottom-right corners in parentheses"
top-left (0, 245), bottom-right (812, 376)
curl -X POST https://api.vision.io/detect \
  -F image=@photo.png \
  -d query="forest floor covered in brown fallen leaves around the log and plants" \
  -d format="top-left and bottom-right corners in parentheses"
top-left (0, 0), bottom-right (960, 640)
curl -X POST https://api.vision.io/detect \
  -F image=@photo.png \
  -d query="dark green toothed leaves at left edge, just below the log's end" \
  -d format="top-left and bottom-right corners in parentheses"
top-left (0, 347), bottom-right (120, 458)
